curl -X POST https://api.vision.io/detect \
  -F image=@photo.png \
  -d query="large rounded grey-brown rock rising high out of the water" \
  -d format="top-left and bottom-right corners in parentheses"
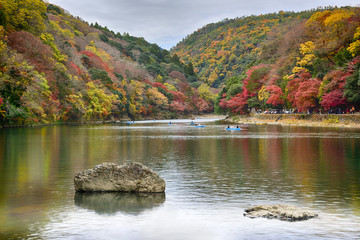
top-left (74, 162), bottom-right (165, 193)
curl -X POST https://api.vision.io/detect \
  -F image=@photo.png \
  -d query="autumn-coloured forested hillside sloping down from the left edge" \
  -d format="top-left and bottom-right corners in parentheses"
top-left (0, 0), bottom-right (213, 125)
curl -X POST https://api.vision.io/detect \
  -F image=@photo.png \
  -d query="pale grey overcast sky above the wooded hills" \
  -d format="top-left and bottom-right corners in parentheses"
top-left (48, 0), bottom-right (359, 49)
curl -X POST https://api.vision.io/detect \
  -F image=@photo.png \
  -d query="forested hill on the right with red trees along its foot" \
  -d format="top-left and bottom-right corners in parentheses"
top-left (172, 7), bottom-right (360, 113)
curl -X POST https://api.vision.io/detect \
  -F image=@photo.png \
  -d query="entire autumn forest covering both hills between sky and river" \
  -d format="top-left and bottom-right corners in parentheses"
top-left (0, 0), bottom-right (360, 125)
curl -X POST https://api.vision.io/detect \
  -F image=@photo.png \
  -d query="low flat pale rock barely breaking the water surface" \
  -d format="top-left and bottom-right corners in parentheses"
top-left (244, 204), bottom-right (318, 222)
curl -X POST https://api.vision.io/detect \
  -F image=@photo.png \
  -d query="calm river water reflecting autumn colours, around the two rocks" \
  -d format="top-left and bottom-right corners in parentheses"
top-left (0, 121), bottom-right (360, 240)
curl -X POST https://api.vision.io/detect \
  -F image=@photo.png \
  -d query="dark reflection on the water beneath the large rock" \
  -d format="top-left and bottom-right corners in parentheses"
top-left (74, 192), bottom-right (165, 215)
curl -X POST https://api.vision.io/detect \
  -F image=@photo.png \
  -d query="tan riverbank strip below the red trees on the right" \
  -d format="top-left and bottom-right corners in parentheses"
top-left (226, 114), bottom-right (360, 128)
